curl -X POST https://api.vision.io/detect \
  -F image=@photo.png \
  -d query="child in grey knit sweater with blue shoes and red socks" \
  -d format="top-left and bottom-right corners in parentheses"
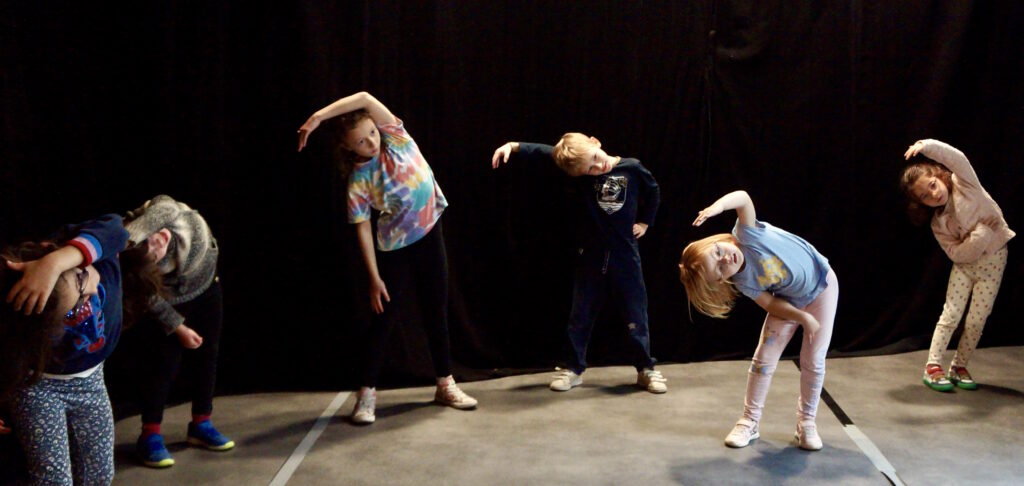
top-left (122, 195), bottom-right (234, 468)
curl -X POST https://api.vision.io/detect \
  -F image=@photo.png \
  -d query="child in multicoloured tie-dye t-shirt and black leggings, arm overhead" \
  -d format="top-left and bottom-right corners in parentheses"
top-left (299, 92), bottom-right (476, 424)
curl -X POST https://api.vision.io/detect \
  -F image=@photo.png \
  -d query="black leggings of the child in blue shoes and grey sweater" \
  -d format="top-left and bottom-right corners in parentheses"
top-left (139, 278), bottom-right (224, 424)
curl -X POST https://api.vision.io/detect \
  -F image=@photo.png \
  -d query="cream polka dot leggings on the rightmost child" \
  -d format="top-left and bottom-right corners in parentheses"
top-left (928, 247), bottom-right (1007, 366)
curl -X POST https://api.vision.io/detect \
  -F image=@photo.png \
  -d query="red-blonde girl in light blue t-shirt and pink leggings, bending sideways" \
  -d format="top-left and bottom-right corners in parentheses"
top-left (679, 190), bottom-right (839, 450)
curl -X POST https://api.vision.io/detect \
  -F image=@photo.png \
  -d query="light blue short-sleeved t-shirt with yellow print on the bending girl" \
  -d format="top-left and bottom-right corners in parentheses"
top-left (730, 219), bottom-right (829, 308)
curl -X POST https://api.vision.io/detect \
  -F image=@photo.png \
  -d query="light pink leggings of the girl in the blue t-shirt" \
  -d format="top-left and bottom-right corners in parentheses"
top-left (743, 270), bottom-right (839, 424)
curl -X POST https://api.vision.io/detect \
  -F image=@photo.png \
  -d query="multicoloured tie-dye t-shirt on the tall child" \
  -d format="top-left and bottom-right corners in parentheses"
top-left (348, 118), bottom-right (447, 252)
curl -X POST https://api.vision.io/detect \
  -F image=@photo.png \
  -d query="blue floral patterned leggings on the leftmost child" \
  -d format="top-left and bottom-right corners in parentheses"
top-left (12, 365), bottom-right (114, 485)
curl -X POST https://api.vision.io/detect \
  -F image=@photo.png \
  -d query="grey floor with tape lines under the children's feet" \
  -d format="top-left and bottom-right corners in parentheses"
top-left (115, 347), bottom-right (1024, 485)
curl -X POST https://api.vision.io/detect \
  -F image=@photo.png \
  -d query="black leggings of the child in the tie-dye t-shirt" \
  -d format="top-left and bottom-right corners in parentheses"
top-left (361, 221), bottom-right (452, 387)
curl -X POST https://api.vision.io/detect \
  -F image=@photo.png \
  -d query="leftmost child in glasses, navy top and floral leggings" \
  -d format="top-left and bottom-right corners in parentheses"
top-left (0, 215), bottom-right (132, 485)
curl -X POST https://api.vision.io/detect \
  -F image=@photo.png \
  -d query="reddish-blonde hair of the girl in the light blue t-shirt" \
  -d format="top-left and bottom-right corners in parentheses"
top-left (679, 233), bottom-right (739, 319)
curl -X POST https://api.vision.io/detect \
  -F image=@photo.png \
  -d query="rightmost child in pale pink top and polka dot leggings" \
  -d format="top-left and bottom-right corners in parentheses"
top-left (900, 139), bottom-right (1016, 392)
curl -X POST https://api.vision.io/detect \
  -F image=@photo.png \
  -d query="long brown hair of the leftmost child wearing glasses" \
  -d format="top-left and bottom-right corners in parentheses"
top-left (0, 241), bottom-right (70, 403)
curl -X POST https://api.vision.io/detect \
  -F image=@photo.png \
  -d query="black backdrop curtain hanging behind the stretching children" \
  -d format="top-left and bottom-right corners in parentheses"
top-left (0, 0), bottom-right (1024, 399)
